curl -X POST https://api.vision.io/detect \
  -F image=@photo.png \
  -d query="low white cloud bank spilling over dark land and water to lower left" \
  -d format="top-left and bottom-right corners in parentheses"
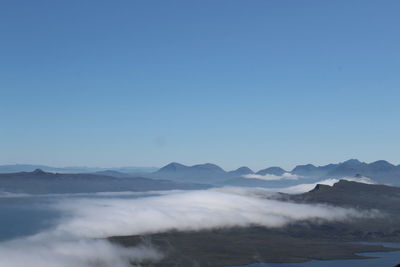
top-left (0, 180), bottom-right (376, 267)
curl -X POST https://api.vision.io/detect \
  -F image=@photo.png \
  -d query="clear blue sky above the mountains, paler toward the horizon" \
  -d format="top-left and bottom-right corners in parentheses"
top-left (0, 0), bottom-right (400, 169)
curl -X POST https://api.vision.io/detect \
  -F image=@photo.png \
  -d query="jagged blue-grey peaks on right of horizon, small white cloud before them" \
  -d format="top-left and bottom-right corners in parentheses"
top-left (146, 159), bottom-right (400, 186)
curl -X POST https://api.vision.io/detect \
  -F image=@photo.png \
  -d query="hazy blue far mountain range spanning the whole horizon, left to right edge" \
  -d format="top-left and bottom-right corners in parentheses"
top-left (0, 159), bottom-right (400, 187)
